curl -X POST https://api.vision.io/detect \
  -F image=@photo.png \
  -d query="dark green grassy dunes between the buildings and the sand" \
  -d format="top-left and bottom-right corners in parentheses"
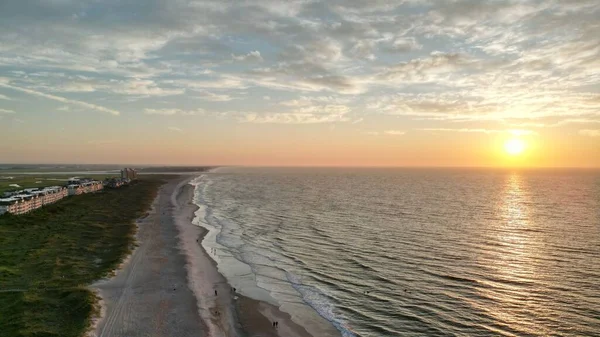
top-left (0, 176), bottom-right (164, 337)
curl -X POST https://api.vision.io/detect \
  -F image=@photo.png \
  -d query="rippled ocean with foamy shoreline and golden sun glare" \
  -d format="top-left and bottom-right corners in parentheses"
top-left (194, 168), bottom-right (600, 336)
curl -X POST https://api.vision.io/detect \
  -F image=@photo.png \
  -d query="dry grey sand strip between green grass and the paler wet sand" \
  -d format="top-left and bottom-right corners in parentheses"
top-left (90, 177), bottom-right (208, 337)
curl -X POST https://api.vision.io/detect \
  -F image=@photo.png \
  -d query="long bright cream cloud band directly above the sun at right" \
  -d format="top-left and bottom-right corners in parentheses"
top-left (366, 87), bottom-right (600, 127)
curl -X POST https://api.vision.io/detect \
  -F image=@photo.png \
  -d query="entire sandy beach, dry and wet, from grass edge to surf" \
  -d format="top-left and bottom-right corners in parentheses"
top-left (90, 176), bottom-right (318, 337)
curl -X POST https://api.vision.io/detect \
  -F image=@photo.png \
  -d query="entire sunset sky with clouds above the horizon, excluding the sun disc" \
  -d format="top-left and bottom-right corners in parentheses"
top-left (0, 0), bottom-right (600, 167)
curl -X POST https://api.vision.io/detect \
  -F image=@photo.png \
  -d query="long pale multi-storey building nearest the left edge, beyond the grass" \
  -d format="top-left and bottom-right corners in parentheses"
top-left (0, 186), bottom-right (68, 214)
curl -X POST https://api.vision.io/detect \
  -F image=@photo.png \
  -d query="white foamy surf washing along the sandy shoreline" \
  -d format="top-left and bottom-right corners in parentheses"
top-left (191, 175), bottom-right (346, 337)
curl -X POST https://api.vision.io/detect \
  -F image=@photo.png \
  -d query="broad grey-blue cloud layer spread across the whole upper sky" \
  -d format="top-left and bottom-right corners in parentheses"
top-left (0, 0), bottom-right (600, 132)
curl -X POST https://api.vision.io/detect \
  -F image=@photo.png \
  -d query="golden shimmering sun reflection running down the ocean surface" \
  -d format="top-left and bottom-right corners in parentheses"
top-left (478, 172), bottom-right (544, 334)
